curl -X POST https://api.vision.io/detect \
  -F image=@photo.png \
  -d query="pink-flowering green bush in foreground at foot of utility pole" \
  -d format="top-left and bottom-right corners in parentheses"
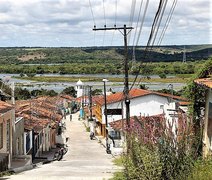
top-left (121, 114), bottom-right (195, 180)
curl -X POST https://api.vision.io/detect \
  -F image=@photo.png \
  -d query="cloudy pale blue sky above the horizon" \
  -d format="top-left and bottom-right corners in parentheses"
top-left (0, 0), bottom-right (212, 47)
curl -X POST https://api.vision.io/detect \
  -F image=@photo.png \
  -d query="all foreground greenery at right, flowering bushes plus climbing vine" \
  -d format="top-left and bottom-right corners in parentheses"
top-left (113, 61), bottom-right (212, 180)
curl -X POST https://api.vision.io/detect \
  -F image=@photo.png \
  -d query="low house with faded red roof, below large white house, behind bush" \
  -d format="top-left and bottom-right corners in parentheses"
top-left (108, 114), bottom-right (166, 155)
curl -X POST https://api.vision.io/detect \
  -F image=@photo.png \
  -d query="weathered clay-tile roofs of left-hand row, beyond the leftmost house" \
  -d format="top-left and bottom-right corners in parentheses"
top-left (15, 96), bottom-right (64, 132)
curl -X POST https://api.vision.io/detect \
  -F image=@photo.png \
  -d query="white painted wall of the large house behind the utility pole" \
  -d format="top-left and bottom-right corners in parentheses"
top-left (102, 94), bottom-right (169, 124)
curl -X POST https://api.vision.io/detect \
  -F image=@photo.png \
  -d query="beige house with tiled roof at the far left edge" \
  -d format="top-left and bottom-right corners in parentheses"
top-left (0, 101), bottom-right (15, 172)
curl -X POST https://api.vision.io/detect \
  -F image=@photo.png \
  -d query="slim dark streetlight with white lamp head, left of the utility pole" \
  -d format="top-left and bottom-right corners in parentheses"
top-left (102, 79), bottom-right (111, 154)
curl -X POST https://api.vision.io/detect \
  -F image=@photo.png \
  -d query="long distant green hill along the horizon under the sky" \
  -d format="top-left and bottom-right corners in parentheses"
top-left (0, 45), bottom-right (212, 64)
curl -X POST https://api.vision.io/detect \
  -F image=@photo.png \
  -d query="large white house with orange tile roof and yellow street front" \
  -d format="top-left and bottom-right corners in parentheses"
top-left (95, 89), bottom-right (186, 136)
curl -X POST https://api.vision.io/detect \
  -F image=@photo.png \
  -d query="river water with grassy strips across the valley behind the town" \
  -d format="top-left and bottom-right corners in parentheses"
top-left (0, 74), bottom-right (185, 93)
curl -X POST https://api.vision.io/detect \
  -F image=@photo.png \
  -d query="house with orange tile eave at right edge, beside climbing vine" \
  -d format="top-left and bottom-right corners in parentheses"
top-left (194, 78), bottom-right (212, 157)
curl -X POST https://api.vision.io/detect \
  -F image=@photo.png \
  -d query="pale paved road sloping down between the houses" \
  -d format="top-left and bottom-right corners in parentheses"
top-left (8, 113), bottom-right (118, 180)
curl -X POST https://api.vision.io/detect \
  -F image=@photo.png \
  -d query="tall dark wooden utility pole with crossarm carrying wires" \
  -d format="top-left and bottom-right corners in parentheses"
top-left (93, 25), bottom-right (133, 128)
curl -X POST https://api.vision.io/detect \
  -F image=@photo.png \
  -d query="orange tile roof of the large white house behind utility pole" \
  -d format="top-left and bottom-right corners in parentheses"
top-left (96, 89), bottom-right (186, 105)
